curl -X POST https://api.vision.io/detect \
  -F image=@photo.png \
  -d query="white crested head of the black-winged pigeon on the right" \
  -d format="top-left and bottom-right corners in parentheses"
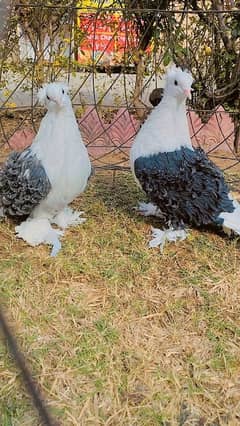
top-left (164, 65), bottom-right (193, 101)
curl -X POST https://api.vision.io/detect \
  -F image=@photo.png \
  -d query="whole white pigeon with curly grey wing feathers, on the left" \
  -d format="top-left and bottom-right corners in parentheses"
top-left (0, 83), bottom-right (91, 256)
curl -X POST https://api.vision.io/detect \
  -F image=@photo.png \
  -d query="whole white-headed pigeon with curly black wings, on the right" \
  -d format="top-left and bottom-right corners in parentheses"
top-left (130, 65), bottom-right (240, 249)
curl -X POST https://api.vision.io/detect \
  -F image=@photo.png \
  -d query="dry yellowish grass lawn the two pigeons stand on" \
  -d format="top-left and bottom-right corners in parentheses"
top-left (0, 173), bottom-right (240, 426)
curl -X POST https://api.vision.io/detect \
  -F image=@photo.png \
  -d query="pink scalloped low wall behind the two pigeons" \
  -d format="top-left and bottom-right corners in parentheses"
top-left (8, 106), bottom-right (238, 163)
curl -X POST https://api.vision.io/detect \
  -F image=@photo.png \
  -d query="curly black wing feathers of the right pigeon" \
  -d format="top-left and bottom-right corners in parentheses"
top-left (134, 148), bottom-right (234, 226)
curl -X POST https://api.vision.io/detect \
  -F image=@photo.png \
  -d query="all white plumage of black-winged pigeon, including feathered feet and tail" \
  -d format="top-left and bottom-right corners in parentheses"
top-left (130, 65), bottom-right (240, 248)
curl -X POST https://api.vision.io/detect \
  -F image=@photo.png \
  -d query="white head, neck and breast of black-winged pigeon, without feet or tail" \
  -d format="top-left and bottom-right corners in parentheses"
top-left (130, 66), bottom-right (193, 172)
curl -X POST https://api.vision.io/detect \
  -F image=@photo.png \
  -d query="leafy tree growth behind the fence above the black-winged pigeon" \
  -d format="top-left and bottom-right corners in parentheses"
top-left (116, 0), bottom-right (240, 145)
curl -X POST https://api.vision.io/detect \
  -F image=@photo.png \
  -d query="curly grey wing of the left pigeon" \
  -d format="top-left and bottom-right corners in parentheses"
top-left (0, 148), bottom-right (51, 218)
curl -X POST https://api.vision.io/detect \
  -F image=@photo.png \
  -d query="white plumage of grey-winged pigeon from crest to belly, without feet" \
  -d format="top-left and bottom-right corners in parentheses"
top-left (31, 83), bottom-right (91, 218)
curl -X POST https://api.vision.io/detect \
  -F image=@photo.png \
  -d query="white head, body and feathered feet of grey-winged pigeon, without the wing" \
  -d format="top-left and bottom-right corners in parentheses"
top-left (16, 83), bottom-right (91, 255)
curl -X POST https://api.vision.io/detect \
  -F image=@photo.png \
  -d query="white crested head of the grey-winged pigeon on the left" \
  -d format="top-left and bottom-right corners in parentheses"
top-left (38, 83), bottom-right (71, 111)
